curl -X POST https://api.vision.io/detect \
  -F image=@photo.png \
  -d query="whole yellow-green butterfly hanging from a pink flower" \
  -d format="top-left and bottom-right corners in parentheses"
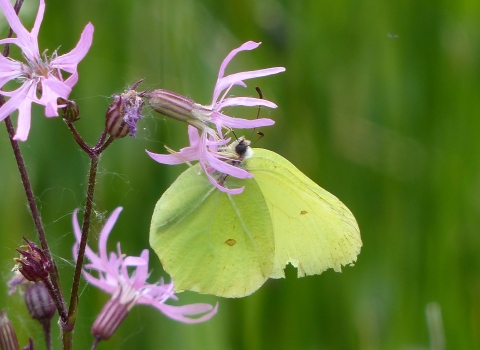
top-left (150, 137), bottom-right (362, 298)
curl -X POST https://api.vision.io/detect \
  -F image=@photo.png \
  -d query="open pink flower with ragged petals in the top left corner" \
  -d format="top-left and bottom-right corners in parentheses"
top-left (0, 0), bottom-right (93, 141)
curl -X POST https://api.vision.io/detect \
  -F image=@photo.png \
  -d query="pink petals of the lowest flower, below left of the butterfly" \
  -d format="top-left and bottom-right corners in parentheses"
top-left (72, 207), bottom-right (218, 323)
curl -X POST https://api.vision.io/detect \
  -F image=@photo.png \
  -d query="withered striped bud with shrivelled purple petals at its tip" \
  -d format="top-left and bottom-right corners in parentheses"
top-left (105, 79), bottom-right (145, 138)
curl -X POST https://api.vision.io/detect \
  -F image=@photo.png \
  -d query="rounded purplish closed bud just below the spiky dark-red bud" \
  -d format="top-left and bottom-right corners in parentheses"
top-left (25, 282), bottom-right (57, 321)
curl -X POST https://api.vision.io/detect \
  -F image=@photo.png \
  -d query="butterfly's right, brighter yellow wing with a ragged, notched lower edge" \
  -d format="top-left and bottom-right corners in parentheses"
top-left (245, 149), bottom-right (362, 278)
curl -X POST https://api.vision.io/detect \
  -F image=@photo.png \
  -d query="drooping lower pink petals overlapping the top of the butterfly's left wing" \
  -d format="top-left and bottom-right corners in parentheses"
top-left (147, 125), bottom-right (253, 194)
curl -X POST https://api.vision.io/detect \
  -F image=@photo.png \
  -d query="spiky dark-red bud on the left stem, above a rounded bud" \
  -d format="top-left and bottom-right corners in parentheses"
top-left (15, 237), bottom-right (51, 282)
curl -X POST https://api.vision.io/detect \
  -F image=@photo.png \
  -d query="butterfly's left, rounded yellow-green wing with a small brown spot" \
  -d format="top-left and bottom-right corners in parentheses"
top-left (150, 165), bottom-right (274, 297)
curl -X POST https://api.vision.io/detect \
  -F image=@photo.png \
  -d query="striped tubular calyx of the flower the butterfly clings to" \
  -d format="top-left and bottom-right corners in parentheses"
top-left (145, 89), bottom-right (205, 130)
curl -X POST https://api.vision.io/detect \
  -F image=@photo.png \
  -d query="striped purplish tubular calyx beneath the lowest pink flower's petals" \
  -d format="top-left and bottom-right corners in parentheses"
top-left (92, 285), bottom-right (138, 341)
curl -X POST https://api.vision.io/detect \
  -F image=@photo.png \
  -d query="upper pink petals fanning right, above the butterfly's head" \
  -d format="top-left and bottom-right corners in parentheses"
top-left (192, 41), bottom-right (285, 135)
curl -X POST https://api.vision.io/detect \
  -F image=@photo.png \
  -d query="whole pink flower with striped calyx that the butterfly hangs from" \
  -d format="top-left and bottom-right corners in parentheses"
top-left (146, 41), bottom-right (285, 194)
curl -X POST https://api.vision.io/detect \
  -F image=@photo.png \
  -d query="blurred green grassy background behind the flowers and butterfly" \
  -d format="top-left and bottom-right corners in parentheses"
top-left (0, 0), bottom-right (480, 349)
